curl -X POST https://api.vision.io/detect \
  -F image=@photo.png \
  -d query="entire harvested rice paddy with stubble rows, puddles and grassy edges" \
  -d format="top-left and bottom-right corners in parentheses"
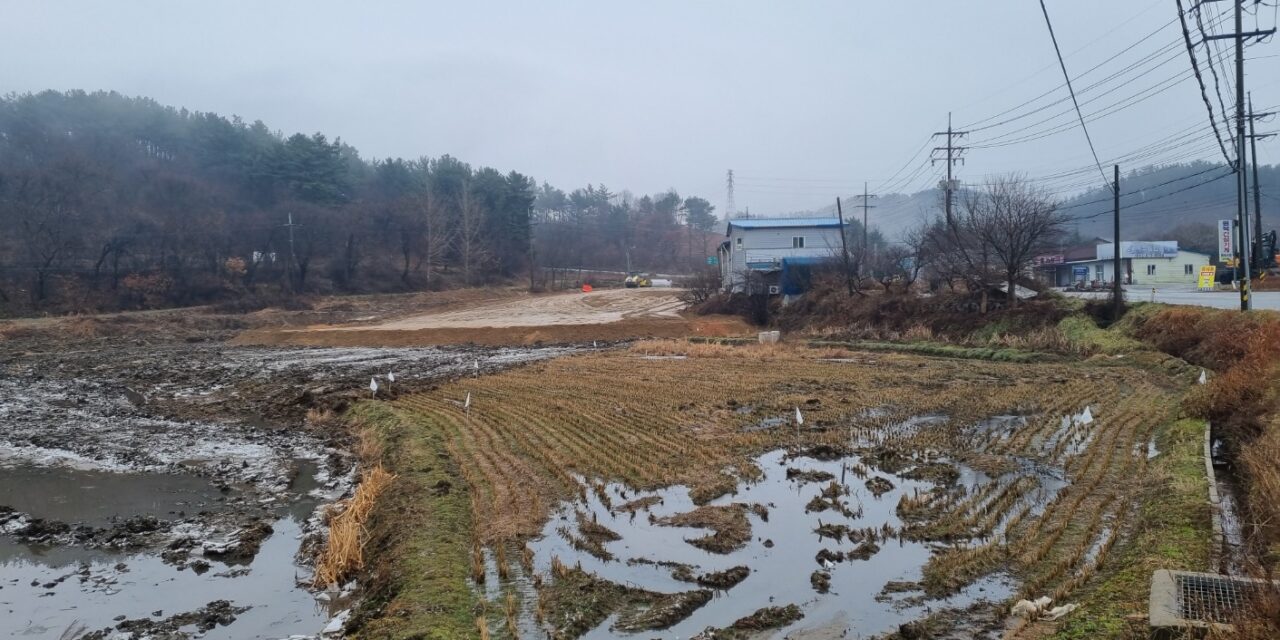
top-left (351, 340), bottom-right (1210, 639)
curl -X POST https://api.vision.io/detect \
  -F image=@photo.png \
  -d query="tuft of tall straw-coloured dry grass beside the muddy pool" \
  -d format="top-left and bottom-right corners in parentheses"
top-left (315, 466), bottom-right (396, 588)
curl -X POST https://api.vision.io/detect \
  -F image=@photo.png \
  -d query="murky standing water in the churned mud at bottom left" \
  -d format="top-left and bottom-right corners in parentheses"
top-left (0, 461), bottom-right (333, 640)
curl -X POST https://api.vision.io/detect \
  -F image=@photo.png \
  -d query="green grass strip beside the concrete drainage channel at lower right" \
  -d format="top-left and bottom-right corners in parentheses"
top-left (1052, 420), bottom-right (1212, 640)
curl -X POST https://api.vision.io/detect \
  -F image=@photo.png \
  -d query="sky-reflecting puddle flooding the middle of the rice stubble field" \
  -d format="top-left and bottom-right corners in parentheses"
top-left (530, 448), bottom-right (1012, 639)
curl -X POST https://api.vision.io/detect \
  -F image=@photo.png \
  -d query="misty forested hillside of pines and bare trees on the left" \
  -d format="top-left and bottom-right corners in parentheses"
top-left (0, 91), bottom-right (716, 314)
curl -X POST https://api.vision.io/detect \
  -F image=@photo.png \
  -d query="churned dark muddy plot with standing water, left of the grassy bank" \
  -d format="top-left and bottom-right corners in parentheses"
top-left (0, 297), bottom-right (573, 637)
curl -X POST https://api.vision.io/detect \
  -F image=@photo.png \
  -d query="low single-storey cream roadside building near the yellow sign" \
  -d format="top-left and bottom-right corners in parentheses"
top-left (1036, 238), bottom-right (1211, 287)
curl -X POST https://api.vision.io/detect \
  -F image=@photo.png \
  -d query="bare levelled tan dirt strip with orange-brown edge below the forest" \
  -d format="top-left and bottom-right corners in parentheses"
top-left (236, 289), bottom-right (750, 347)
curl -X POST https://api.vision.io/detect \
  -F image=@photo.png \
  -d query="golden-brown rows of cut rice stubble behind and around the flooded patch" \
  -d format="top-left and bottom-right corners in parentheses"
top-left (396, 340), bottom-right (1175, 586)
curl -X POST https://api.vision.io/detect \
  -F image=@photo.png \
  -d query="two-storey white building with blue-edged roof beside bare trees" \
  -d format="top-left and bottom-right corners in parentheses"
top-left (717, 218), bottom-right (844, 293)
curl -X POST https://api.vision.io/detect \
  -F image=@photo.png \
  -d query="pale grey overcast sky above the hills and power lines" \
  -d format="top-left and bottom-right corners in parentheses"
top-left (0, 0), bottom-right (1280, 214)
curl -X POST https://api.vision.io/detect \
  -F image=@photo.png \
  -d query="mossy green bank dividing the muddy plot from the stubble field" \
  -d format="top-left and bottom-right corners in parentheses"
top-left (348, 401), bottom-right (477, 640)
